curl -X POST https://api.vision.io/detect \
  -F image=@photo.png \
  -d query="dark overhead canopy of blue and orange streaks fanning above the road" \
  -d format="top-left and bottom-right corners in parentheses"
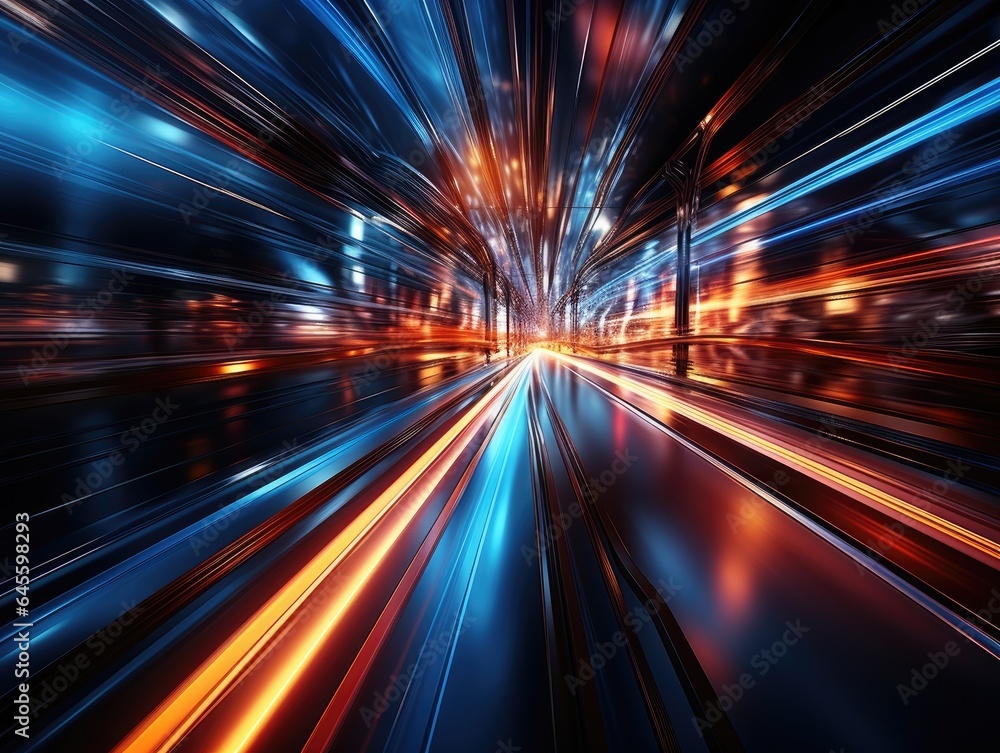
top-left (2, 0), bottom-right (996, 326)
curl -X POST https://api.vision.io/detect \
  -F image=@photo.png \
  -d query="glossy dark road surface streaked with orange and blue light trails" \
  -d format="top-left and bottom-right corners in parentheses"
top-left (6, 349), bottom-right (1000, 751)
